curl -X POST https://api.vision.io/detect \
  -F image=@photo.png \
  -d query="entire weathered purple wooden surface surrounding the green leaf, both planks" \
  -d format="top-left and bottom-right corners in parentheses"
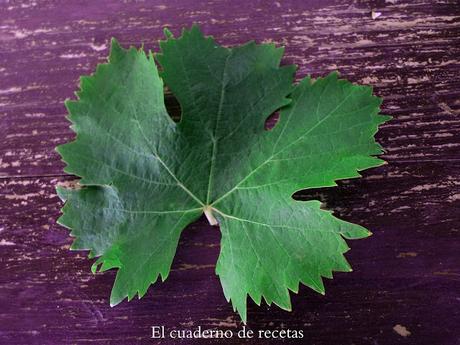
top-left (0, 0), bottom-right (460, 344)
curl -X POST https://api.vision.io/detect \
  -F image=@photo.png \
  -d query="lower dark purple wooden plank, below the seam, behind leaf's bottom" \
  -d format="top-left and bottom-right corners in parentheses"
top-left (0, 162), bottom-right (460, 344)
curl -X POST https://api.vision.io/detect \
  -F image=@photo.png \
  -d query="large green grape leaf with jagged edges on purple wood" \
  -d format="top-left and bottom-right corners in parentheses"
top-left (57, 26), bottom-right (389, 322)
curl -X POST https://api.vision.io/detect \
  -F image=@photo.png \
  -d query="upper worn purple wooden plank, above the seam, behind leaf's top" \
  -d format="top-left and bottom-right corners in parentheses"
top-left (0, 1), bottom-right (460, 176)
